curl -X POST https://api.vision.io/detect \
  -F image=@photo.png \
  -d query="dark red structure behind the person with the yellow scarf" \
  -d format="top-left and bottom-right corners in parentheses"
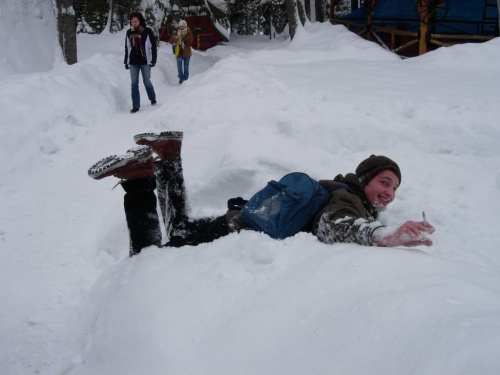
top-left (160, 16), bottom-right (229, 51)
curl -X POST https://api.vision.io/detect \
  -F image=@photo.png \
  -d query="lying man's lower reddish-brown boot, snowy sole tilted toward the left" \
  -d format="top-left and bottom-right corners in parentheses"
top-left (88, 146), bottom-right (154, 180)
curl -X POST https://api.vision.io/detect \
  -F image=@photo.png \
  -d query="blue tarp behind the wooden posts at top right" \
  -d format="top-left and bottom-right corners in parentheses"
top-left (341, 0), bottom-right (498, 35)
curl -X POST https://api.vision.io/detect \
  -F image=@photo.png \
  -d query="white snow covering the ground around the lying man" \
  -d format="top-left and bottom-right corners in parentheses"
top-left (0, 4), bottom-right (500, 375)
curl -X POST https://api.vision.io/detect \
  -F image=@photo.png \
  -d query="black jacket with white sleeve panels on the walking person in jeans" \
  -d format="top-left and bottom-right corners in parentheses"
top-left (123, 25), bottom-right (156, 65)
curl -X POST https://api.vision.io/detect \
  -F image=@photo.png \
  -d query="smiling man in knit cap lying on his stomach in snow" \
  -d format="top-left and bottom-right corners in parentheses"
top-left (88, 131), bottom-right (434, 256)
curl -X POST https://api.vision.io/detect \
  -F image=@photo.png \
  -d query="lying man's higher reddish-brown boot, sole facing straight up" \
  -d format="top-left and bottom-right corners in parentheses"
top-left (134, 131), bottom-right (183, 160)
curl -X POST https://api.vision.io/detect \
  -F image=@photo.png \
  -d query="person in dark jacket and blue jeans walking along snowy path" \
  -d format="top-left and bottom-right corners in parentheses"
top-left (124, 12), bottom-right (156, 113)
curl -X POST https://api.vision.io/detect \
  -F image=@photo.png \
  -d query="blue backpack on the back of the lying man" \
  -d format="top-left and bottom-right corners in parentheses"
top-left (241, 172), bottom-right (329, 239)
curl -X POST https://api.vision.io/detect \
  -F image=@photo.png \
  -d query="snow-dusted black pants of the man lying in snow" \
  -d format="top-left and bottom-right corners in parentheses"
top-left (121, 158), bottom-right (229, 256)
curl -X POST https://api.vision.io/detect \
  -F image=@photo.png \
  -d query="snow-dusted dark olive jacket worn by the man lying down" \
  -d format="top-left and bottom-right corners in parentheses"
top-left (226, 173), bottom-right (384, 246)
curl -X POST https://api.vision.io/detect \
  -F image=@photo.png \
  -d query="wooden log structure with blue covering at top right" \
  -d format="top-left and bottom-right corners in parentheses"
top-left (330, 0), bottom-right (499, 56)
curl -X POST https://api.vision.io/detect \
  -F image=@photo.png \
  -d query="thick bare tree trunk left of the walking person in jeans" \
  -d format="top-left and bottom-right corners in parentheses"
top-left (56, 0), bottom-right (78, 65)
